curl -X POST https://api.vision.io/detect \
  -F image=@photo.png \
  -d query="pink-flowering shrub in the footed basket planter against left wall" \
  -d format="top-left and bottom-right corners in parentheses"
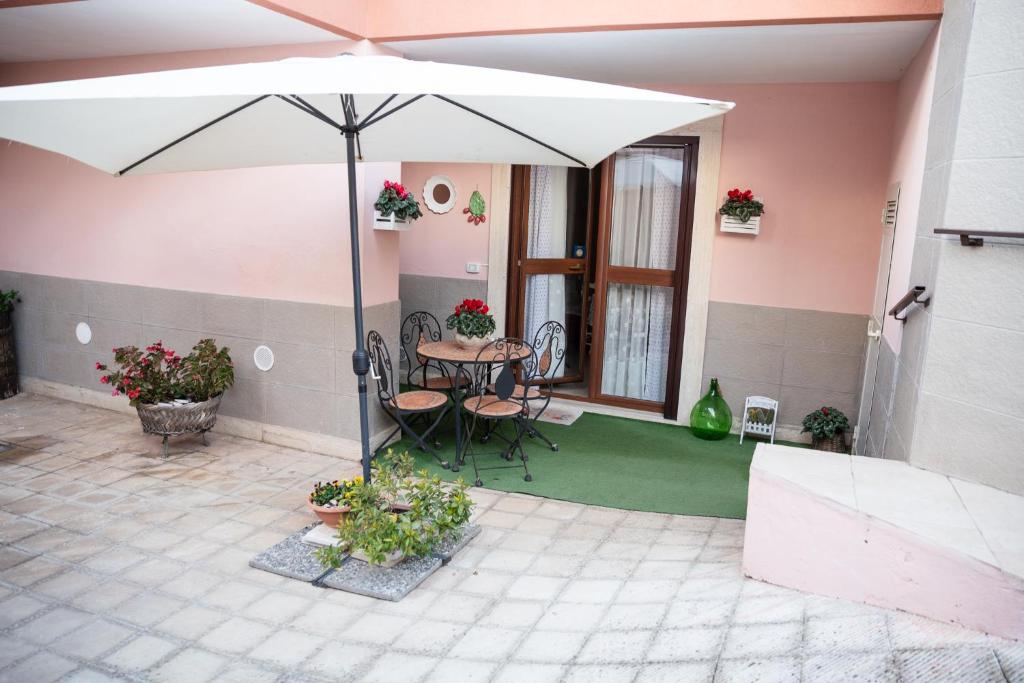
top-left (96, 339), bottom-right (234, 405)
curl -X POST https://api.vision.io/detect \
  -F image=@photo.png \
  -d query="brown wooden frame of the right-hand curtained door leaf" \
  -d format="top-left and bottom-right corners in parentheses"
top-left (588, 135), bottom-right (700, 420)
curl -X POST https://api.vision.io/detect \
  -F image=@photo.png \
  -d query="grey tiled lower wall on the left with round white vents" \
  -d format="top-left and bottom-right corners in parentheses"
top-left (0, 270), bottom-right (399, 439)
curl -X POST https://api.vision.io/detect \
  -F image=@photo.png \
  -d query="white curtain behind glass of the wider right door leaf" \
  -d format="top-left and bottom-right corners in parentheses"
top-left (601, 147), bottom-right (683, 401)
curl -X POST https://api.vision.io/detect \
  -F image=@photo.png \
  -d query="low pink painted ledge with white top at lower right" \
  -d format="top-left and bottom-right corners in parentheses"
top-left (743, 444), bottom-right (1024, 640)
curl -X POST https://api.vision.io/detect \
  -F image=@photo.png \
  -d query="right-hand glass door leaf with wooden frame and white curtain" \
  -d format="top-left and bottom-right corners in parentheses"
top-left (594, 137), bottom-right (696, 418)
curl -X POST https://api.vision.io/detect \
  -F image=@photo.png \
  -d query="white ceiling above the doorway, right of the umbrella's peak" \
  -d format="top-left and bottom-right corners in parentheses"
top-left (386, 20), bottom-right (935, 83)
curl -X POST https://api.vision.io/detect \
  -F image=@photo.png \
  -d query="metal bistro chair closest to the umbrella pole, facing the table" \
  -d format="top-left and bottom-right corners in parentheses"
top-left (367, 330), bottom-right (449, 468)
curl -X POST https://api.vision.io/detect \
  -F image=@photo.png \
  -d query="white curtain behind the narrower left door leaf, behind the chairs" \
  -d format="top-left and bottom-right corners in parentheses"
top-left (523, 166), bottom-right (568, 376)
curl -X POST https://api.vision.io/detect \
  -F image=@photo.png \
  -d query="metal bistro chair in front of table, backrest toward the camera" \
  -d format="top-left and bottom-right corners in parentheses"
top-left (459, 337), bottom-right (537, 486)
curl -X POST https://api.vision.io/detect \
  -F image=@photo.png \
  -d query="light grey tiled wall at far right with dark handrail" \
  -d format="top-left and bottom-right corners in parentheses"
top-left (884, 0), bottom-right (1024, 494)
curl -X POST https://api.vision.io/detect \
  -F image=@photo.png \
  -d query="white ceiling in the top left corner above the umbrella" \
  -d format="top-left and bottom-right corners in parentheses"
top-left (0, 0), bottom-right (340, 61)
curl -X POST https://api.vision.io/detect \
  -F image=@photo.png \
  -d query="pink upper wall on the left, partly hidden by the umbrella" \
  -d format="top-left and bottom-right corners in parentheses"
top-left (0, 43), bottom-right (400, 305)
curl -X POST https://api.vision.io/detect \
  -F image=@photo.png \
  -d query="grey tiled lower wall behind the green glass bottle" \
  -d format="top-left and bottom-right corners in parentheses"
top-left (703, 301), bottom-right (867, 425)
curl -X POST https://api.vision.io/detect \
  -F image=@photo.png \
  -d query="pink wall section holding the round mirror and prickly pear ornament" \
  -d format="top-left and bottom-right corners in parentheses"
top-left (400, 164), bottom-right (490, 280)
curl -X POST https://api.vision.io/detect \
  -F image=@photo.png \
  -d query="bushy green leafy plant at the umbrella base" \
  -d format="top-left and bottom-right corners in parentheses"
top-left (316, 450), bottom-right (473, 568)
